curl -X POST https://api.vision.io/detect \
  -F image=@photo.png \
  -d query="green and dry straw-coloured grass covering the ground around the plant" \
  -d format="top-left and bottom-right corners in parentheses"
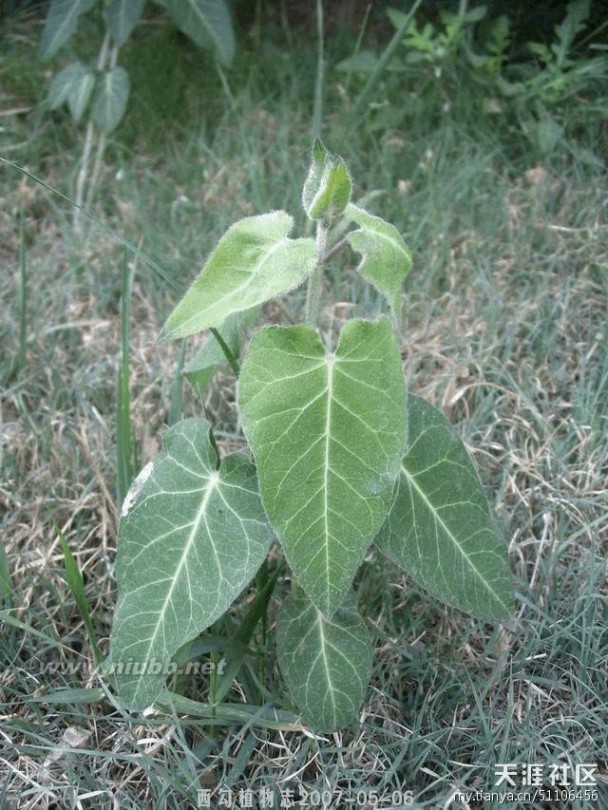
top-left (0, 7), bottom-right (608, 810)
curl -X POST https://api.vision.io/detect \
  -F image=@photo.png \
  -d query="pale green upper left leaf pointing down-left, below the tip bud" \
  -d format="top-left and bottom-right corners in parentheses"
top-left (159, 211), bottom-right (317, 340)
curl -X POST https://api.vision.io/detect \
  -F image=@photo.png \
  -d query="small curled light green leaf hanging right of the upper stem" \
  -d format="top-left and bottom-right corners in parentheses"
top-left (346, 204), bottom-right (412, 321)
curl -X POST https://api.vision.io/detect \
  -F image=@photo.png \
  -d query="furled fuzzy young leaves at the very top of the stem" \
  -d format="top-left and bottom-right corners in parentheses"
top-left (302, 138), bottom-right (352, 220)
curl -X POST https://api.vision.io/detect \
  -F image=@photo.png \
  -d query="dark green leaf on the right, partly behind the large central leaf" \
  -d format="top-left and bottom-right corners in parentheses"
top-left (376, 394), bottom-right (513, 621)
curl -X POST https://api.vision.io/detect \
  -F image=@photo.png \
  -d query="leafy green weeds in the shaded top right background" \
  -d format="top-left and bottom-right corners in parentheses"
top-left (337, 0), bottom-right (608, 158)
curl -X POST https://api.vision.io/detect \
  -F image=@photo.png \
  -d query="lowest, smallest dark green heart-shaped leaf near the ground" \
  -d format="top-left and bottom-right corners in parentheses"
top-left (277, 595), bottom-right (373, 733)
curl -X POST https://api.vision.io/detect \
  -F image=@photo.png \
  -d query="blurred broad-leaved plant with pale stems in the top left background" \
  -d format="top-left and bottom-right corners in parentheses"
top-left (40, 0), bottom-right (234, 224)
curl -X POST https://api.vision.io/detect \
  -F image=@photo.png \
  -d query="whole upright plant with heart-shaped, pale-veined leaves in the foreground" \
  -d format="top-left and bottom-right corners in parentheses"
top-left (109, 141), bottom-right (513, 731)
